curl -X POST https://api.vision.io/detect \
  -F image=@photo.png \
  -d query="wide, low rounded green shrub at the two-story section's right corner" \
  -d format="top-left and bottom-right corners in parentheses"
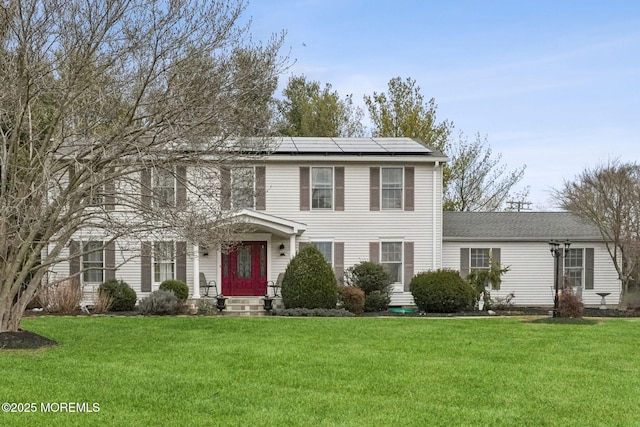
top-left (410, 270), bottom-right (476, 313)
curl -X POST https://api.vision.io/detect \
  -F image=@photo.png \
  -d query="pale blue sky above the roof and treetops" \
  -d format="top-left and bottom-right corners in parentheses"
top-left (245, 0), bottom-right (640, 210)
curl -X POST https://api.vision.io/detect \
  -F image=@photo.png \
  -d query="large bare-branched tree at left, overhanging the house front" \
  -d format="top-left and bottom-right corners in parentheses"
top-left (0, 0), bottom-right (286, 332)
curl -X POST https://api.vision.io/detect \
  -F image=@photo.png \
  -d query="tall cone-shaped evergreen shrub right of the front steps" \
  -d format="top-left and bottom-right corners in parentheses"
top-left (281, 245), bottom-right (338, 308)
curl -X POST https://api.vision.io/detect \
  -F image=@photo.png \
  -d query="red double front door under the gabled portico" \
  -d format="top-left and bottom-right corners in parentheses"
top-left (222, 242), bottom-right (267, 296)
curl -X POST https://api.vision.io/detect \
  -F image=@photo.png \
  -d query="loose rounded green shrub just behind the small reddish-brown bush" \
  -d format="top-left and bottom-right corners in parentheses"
top-left (345, 261), bottom-right (393, 312)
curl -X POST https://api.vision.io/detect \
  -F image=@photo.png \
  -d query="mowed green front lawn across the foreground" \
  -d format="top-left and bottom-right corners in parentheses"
top-left (0, 317), bottom-right (640, 426)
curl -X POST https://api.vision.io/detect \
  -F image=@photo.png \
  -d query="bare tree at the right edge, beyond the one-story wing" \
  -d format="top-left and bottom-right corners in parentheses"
top-left (554, 160), bottom-right (640, 306)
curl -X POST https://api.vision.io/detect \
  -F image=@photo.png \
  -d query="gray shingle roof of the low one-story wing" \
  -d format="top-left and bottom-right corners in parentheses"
top-left (442, 211), bottom-right (602, 241)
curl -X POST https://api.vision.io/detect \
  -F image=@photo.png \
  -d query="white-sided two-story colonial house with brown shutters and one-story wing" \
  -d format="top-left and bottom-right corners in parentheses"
top-left (56, 138), bottom-right (619, 306)
